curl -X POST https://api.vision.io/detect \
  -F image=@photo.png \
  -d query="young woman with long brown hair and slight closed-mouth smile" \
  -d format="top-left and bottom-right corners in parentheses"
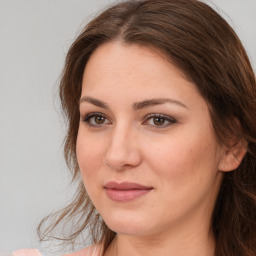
top-left (13, 0), bottom-right (256, 256)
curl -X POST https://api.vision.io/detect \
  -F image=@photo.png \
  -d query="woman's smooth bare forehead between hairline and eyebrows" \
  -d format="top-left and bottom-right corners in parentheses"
top-left (82, 42), bottom-right (205, 110)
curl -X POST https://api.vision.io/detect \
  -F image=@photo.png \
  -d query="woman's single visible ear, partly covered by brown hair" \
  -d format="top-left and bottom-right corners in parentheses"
top-left (219, 139), bottom-right (248, 172)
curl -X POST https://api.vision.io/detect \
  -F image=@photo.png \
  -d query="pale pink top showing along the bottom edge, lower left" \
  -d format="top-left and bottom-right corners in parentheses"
top-left (12, 245), bottom-right (101, 256)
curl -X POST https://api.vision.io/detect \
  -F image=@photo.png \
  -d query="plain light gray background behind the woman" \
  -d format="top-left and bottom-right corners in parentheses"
top-left (0, 0), bottom-right (256, 253)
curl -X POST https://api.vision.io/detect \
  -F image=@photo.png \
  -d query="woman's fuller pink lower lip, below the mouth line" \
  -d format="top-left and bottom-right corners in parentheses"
top-left (106, 188), bottom-right (151, 202)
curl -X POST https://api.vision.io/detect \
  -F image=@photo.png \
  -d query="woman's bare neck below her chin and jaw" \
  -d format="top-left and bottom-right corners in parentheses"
top-left (104, 213), bottom-right (215, 256)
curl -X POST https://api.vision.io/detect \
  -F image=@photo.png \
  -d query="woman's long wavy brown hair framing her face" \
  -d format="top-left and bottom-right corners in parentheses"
top-left (38, 0), bottom-right (256, 256)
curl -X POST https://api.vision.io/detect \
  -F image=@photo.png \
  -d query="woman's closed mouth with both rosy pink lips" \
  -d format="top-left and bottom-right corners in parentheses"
top-left (104, 182), bottom-right (153, 202)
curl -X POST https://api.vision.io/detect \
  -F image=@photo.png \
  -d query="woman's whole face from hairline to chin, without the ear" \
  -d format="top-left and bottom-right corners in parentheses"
top-left (77, 42), bottom-right (223, 235)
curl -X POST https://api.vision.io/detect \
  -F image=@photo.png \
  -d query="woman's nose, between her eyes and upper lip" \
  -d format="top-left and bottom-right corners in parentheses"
top-left (104, 124), bottom-right (142, 171)
